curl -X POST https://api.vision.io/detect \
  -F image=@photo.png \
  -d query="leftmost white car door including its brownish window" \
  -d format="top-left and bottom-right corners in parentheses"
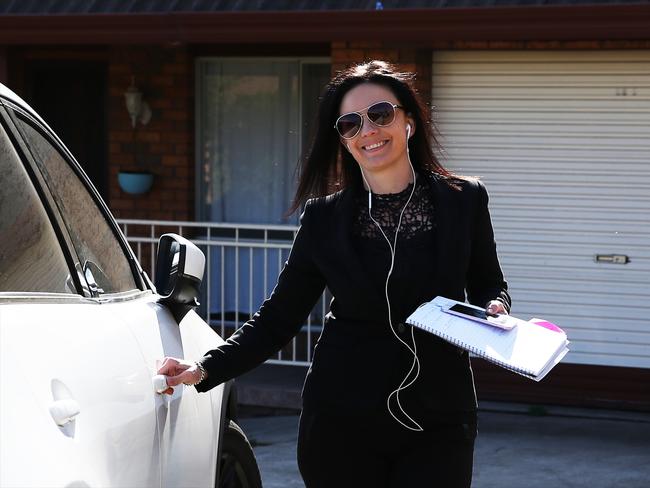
top-left (0, 106), bottom-right (161, 487)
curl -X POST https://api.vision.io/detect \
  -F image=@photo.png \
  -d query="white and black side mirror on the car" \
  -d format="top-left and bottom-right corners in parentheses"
top-left (155, 234), bottom-right (205, 322)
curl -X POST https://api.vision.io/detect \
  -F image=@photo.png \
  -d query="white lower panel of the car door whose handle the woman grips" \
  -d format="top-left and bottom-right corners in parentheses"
top-left (108, 296), bottom-right (223, 486)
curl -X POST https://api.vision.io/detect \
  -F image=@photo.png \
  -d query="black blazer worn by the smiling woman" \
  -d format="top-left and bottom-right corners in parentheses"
top-left (197, 174), bottom-right (510, 420)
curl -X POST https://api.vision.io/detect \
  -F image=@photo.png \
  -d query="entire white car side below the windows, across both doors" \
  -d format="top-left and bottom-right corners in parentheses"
top-left (0, 294), bottom-right (225, 487)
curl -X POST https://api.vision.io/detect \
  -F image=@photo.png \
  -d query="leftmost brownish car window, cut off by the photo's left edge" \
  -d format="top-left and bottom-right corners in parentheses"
top-left (0, 119), bottom-right (76, 293)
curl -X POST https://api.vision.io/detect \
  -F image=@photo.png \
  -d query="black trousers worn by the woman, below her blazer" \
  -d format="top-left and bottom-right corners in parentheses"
top-left (298, 410), bottom-right (477, 488)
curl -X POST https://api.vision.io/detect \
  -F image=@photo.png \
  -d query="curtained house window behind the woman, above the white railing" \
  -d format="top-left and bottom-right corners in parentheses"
top-left (197, 59), bottom-right (330, 224)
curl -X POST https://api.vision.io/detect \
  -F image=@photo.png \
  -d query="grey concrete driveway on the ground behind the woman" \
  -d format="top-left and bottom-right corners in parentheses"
top-left (240, 404), bottom-right (650, 488)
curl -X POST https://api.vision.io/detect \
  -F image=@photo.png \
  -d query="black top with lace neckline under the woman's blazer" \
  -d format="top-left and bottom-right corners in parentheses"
top-left (352, 179), bottom-right (435, 324)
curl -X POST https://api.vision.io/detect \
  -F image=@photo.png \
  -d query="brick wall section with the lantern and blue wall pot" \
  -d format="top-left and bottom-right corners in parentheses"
top-left (108, 46), bottom-right (195, 220)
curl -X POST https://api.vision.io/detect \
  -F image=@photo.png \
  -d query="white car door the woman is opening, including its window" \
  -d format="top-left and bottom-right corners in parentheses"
top-left (5, 93), bottom-right (222, 486)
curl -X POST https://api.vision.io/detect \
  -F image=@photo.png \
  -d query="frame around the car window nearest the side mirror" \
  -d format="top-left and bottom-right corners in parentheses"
top-left (2, 99), bottom-right (153, 302)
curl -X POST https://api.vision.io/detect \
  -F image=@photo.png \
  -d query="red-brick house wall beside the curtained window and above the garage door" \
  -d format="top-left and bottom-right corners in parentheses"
top-left (104, 40), bottom-right (650, 220)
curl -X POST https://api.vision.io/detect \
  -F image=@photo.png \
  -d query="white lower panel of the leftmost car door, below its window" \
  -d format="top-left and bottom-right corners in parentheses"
top-left (0, 300), bottom-right (161, 487)
